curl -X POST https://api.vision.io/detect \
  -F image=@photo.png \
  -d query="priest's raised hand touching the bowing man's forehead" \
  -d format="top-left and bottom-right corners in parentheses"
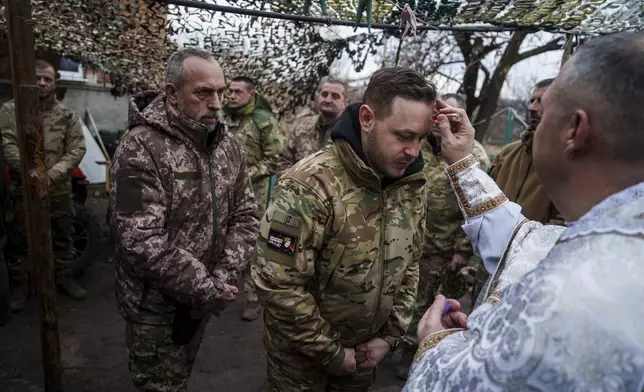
top-left (432, 99), bottom-right (474, 165)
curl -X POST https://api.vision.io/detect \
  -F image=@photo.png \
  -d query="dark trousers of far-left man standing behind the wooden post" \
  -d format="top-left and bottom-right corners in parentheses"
top-left (5, 195), bottom-right (74, 285)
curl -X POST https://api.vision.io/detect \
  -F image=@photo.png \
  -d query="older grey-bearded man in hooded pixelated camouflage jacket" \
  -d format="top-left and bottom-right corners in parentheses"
top-left (110, 49), bottom-right (258, 392)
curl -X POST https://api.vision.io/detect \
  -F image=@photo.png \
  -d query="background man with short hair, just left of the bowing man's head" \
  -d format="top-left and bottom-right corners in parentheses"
top-left (278, 79), bottom-right (349, 175)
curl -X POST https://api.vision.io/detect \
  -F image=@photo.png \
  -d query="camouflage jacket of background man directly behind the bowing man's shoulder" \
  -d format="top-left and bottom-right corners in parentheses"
top-left (277, 115), bottom-right (333, 175)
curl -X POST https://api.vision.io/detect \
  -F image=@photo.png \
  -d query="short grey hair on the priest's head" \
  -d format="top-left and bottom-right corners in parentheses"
top-left (556, 32), bottom-right (644, 164)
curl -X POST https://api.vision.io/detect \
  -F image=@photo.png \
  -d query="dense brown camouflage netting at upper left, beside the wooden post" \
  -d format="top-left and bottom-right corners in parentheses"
top-left (0, 0), bottom-right (176, 94)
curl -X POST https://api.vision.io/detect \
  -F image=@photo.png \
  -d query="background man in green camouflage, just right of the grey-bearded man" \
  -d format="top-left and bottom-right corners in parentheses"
top-left (225, 76), bottom-right (284, 321)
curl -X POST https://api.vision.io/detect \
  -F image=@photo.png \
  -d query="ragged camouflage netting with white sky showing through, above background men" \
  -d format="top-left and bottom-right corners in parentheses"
top-left (169, 3), bottom-right (382, 114)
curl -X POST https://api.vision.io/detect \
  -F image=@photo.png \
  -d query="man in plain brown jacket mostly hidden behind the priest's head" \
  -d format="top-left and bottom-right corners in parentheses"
top-left (488, 79), bottom-right (564, 225)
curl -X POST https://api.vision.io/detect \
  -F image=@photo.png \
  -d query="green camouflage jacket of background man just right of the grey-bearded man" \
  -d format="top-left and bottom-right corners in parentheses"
top-left (226, 99), bottom-right (284, 212)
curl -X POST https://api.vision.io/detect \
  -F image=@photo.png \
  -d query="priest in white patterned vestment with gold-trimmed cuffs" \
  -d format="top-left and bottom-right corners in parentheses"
top-left (404, 33), bottom-right (644, 392)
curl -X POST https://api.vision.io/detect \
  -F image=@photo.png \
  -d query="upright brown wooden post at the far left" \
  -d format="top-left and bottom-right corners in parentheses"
top-left (6, 0), bottom-right (63, 392)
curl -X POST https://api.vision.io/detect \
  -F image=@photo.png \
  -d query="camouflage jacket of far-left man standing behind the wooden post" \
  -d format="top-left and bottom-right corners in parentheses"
top-left (0, 97), bottom-right (85, 196)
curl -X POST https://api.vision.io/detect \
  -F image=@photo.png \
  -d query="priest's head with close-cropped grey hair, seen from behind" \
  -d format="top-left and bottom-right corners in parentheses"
top-left (533, 33), bottom-right (644, 221)
